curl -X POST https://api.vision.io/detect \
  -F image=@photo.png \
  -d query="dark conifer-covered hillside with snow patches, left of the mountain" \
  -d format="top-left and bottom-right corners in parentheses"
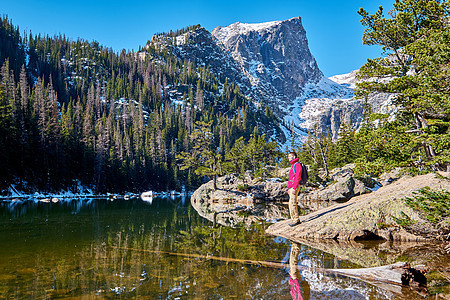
top-left (0, 17), bottom-right (277, 192)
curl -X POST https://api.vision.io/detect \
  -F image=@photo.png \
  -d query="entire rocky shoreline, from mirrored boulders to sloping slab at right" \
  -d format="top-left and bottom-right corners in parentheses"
top-left (191, 167), bottom-right (450, 242)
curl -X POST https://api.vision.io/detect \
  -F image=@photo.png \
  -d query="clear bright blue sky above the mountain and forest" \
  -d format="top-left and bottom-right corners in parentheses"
top-left (0, 0), bottom-right (394, 77)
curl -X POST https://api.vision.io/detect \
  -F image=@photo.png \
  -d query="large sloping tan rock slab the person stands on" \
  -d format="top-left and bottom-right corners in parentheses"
top-left (266, 172), bottom-right (450, 241)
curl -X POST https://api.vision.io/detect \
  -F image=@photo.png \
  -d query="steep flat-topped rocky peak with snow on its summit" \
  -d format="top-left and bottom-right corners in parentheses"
top-left (211, 17), bottom-right (323, 115)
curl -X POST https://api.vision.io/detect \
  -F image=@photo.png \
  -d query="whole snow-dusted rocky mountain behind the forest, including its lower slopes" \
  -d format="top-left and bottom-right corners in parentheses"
top-left (148, 17), bottom-right (389, 141)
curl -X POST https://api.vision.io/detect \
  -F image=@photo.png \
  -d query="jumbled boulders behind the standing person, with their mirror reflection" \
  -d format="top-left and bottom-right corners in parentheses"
top-left (191, 165), bottom-right (380, 225)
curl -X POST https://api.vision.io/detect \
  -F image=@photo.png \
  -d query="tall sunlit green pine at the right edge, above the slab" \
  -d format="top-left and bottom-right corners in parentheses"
top-left (358, 0), bottom-right (450, 169)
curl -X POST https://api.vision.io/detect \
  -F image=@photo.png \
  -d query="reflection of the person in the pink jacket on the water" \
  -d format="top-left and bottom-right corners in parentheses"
top-left (289, 242), bottom-right (309, 300)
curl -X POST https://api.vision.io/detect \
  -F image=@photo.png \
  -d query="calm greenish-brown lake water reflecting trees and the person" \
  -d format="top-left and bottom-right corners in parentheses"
top-left (0, 198), bottom-right (440, 299)
